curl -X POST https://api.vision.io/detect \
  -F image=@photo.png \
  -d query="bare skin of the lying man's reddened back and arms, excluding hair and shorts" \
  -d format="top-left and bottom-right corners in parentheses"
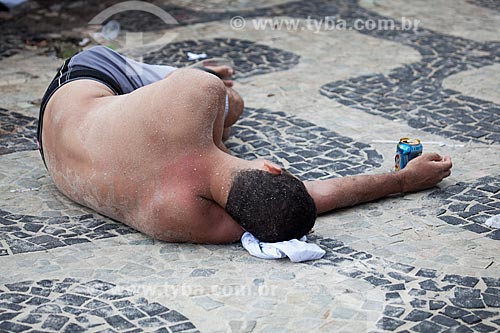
top-left (42, 68), bottom-right (451, 243)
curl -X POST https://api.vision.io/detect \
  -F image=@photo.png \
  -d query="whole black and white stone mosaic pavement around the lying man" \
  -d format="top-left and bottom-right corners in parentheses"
top-left (0, 0), bottom-right (500, 332)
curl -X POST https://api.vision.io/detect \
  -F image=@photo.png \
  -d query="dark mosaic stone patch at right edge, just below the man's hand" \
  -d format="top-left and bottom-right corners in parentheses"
top-left (430, 175), bottom-right (500, 240)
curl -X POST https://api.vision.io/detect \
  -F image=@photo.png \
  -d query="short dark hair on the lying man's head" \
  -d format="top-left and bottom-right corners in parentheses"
top-left (226, 169), bottom-right (316, 242)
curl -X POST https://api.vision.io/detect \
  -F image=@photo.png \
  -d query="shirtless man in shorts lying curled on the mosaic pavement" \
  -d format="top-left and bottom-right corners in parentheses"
top-left (38, 46), bottom-right (452, 243)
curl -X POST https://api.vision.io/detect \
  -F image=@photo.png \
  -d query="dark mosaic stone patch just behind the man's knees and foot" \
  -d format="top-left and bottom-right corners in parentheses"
top-left (144, 38), bottom-right (299, 79)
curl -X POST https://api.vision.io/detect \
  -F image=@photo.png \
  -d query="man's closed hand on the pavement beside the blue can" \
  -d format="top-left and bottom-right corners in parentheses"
top-left (398, 153), bottom-right (452, 192)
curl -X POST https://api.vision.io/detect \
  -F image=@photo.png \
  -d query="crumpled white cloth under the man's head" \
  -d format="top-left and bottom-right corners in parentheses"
top-left (241, 232), bottom-right (326, 262)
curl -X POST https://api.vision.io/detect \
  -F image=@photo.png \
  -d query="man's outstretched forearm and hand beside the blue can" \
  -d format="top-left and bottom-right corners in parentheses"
top-left (305, 153), bottom-right (452, 214)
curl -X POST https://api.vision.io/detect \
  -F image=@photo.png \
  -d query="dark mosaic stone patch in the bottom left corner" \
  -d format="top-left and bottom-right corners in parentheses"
top-left (0, 278), bottom-right (199, 333)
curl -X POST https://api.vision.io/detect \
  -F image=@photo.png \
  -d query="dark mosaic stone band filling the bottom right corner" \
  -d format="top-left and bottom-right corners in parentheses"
top-left (308, 236), bottom-right (500, 333)
